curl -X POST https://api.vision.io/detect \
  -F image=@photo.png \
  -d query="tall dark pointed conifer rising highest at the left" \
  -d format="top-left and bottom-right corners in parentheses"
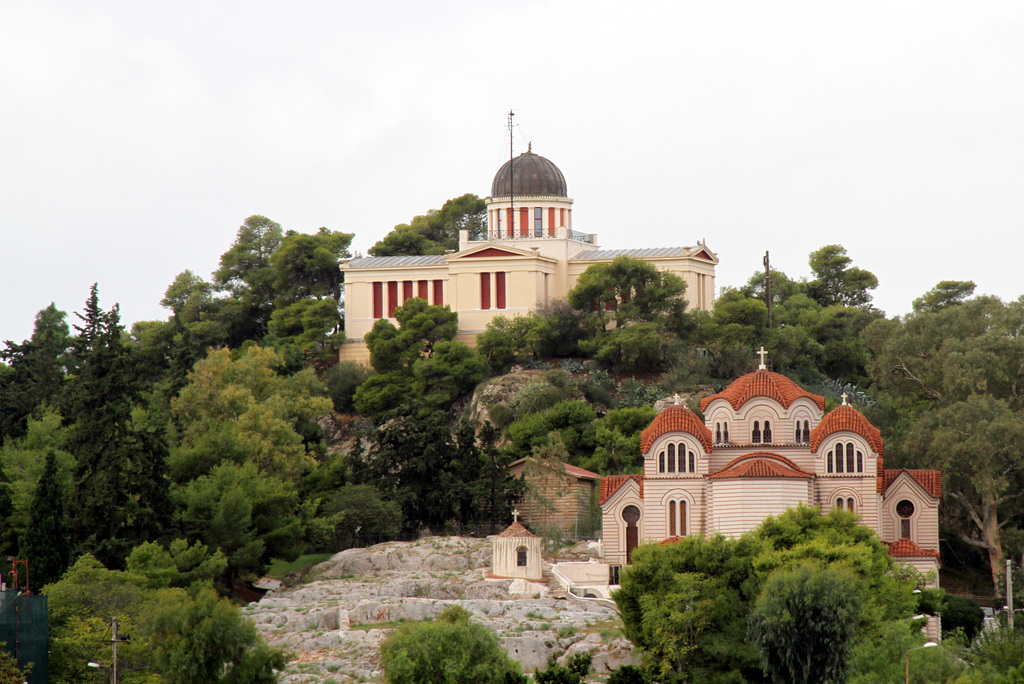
top-left (65, 285), bottom-right (170, 568)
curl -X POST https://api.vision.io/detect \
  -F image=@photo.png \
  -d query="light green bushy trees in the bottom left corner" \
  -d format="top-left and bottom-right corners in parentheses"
top-left (46, 542), bottom-right (285, 684)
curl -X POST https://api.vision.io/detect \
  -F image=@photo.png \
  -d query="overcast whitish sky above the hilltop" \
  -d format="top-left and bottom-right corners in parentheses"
top-left (0, 0), bottom-right (1024, 341)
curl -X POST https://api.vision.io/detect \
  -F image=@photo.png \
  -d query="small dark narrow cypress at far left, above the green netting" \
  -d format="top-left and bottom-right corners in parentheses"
top-left (19, 451), bottom-right (71, 588)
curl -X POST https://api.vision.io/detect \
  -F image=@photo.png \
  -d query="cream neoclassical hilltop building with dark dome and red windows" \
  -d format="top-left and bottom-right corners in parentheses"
top-left (340, 148), bottom-right (718, 361)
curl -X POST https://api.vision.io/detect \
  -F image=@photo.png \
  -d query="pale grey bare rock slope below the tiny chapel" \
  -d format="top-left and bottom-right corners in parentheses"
top-left (246, 537), bottom-right (636, 684)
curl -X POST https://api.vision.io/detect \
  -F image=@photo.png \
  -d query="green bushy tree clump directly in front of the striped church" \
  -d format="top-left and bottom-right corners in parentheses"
top-left (614, 508), bottom-right (918, 682)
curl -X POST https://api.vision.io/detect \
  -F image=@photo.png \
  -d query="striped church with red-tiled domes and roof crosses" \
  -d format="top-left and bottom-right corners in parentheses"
top-left (598, 349), bottom-right (942, 586)
